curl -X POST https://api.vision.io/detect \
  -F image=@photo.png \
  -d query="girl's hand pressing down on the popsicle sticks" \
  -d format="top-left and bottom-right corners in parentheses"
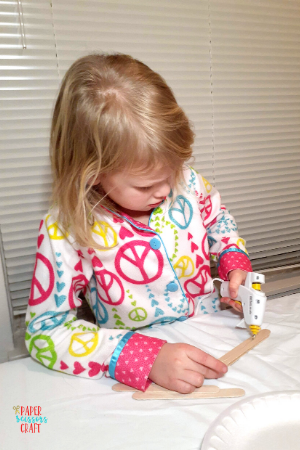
top-left (149, 344), bottom-right (228, 394)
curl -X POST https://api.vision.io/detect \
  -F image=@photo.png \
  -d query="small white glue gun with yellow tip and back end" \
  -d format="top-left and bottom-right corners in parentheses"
top-left (220, 272), bottom-right (267, 336)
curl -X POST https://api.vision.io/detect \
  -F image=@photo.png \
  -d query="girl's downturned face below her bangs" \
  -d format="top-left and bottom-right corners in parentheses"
top-left (101, 167), bottom-right (173, 215)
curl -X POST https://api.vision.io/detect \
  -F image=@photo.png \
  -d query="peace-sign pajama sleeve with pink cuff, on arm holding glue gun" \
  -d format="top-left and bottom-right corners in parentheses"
top-left (198, 175), bottom-right (252, 280)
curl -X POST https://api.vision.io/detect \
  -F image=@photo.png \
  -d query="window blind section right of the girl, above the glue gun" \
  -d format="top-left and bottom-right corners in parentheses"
top-left (209, 0), bottom-right (300, 269)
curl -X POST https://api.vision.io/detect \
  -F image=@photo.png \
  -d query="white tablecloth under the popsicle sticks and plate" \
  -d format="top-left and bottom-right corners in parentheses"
top-left (0, 294), bottom-right (300, 450)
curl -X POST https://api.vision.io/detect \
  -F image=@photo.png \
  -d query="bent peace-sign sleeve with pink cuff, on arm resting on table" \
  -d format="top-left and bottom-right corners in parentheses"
top-left (25, 215), bottom-right (165, 390)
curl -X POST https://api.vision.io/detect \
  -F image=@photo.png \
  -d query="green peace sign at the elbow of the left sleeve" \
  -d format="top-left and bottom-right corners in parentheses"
top-left (28, 334), bottom-right (57, 369)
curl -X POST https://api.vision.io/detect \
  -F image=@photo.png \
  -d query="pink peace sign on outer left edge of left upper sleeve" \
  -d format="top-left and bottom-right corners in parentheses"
top-left (28, 253), bottom-right (54, 306)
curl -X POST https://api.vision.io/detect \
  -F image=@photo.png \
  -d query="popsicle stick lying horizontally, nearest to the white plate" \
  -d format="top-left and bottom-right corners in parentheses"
top-left (132, 388), bottom-right (245, 400)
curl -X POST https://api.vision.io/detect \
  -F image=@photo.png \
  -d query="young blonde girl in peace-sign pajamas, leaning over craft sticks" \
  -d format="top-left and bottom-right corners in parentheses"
top-left (25, 54), bottom-right (251, 393)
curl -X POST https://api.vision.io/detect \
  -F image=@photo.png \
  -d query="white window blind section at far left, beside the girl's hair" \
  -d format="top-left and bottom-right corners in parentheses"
top-left (0, 0), bottom-right (59, 321)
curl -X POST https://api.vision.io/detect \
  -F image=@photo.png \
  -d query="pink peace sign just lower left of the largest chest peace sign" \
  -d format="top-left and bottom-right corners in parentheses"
top-left (95, 269), bottom-right (125, 305)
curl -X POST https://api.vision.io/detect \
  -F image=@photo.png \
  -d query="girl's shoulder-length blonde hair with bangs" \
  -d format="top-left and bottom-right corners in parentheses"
top-left (50, 54), bottom-right (194, 248)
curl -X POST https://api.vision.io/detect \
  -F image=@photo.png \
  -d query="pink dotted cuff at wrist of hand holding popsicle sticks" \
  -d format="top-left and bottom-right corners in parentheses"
top-left (115, 333), bottom-right (167, 391)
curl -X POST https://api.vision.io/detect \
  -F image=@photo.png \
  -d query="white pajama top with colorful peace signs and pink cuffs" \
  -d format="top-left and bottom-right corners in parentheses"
top-left (25, 168), bottom-right (252, 390)
